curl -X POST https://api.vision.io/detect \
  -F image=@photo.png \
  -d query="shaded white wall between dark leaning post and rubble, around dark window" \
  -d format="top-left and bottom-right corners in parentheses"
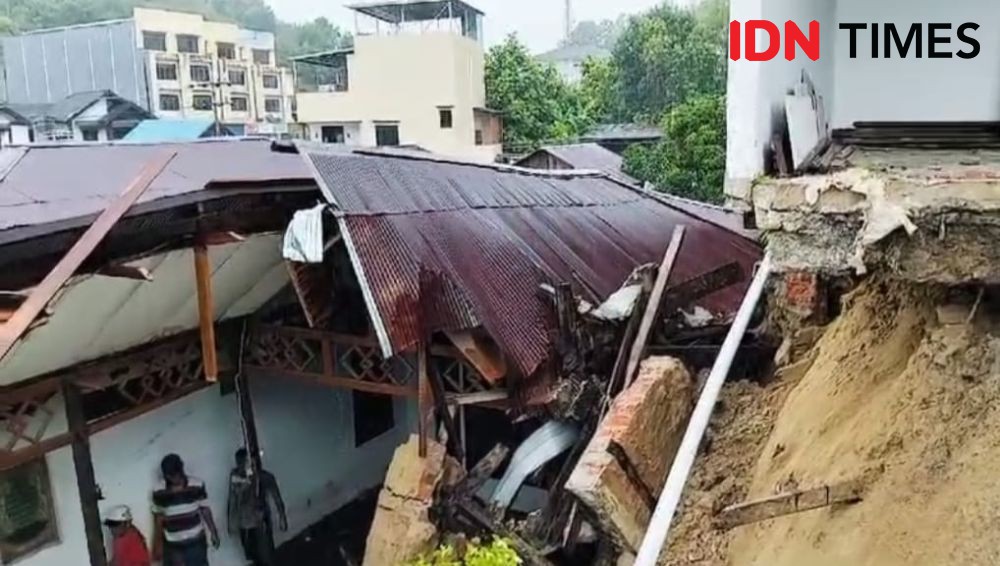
top-left (251, 378), bottom-right (417, 543)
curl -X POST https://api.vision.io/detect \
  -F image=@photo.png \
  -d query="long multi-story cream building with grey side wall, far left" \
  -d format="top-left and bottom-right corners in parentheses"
top-left (3, 8), bottom-right (293, 134)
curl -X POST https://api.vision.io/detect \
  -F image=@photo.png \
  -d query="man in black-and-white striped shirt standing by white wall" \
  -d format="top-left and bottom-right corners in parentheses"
top-left (153, 454), bottom-right (219, 566)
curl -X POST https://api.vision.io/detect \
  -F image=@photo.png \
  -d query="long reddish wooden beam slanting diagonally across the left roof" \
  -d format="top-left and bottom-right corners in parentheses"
top-left (0, 151), bottom-right (177, 360)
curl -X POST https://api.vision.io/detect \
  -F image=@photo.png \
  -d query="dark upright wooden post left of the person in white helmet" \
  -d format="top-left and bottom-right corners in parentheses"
top-left (62, 380), bottom-right (108, 566)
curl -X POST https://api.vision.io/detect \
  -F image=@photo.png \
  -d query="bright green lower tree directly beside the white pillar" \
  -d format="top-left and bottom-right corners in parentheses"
top-left (625, 94), bottom-right (726, 203)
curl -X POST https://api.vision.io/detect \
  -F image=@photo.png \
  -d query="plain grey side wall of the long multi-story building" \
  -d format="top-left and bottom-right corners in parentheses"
top-left (2, 20), bottom-right (149, 109)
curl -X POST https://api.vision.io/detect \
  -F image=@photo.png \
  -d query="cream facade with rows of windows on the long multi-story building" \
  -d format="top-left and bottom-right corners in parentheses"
top-left (134, 8), bottom-right (294, 134)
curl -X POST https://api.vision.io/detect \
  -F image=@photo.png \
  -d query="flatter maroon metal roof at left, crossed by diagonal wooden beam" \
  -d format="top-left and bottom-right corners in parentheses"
top-left (0, 139), bottom-right (312, 244)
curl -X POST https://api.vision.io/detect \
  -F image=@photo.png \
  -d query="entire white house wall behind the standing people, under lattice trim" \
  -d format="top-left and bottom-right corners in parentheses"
top-left (18, 379), bottom-right (416, 566)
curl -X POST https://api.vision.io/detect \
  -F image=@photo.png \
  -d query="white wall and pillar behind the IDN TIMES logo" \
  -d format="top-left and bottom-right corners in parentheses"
top-left (726, 0), bottom-right (1000, 200)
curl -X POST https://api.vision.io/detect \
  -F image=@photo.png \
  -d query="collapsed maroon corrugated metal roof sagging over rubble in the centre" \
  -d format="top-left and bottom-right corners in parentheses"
top-left (303, 149), bottom-right (760, 382)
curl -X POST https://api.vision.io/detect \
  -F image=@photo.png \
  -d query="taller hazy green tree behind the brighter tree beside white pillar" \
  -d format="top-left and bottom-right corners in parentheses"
top-left (614, 4), bottom-right (726, 122)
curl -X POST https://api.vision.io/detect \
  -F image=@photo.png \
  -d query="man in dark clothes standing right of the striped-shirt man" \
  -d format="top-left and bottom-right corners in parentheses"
top-left (228, 448), bottom-right (288, 566)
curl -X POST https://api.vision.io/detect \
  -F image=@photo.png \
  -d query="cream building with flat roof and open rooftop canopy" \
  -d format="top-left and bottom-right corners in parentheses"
top-left (293, 0), bottom-right (502, 161)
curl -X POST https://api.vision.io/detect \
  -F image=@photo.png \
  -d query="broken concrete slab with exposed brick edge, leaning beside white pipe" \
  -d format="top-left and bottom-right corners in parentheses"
top-left (566, 357), bottom-right (695, 551)
